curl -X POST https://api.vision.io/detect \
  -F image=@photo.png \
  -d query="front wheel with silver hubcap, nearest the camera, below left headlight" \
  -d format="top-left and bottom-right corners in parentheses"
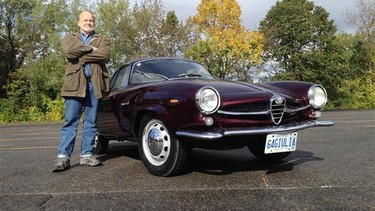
top-left (138, 115), bottom-right (187, 176)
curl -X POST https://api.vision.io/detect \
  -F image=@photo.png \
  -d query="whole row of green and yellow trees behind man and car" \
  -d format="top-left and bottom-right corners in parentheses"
top-left (0, 0), bottom-right (375, 123)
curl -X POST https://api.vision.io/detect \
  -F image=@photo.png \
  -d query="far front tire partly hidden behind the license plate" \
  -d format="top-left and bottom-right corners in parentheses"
top-left (247, 137), bottom-right (291, 162)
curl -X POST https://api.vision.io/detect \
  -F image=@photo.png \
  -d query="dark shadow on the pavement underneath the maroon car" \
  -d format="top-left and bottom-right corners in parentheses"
top-left (93, 142), bottom-right (324, 175)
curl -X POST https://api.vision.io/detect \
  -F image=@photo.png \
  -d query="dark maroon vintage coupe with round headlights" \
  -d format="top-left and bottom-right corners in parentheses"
top-left (95, 58), bottom-right (334, 176)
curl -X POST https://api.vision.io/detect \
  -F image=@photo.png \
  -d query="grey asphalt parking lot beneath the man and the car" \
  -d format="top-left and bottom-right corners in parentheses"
top-left (0, 110), bottom-right (375, 210)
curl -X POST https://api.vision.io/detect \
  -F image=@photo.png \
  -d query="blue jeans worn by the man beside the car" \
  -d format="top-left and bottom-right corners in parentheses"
top-left (57, 82), bottom-right (100, 159)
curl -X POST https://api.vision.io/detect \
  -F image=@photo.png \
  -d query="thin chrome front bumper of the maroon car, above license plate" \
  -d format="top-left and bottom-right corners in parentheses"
top-left (176, 121), bottom-right (335, 140)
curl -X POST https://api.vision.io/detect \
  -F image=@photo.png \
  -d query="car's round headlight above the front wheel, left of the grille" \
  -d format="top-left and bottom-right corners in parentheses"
top-left (195, 87), bottom-right (220, 113)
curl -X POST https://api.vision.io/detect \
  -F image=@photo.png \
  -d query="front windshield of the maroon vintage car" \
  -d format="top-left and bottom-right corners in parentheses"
top-left (132, 59), bottom-right (213, 83)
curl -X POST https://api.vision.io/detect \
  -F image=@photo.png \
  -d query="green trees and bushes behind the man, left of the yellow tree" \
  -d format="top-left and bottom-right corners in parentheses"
top-left (0, 0), bottom-right (200, 122)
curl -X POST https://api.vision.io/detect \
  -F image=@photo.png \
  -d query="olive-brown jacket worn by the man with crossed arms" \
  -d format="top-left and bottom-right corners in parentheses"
top-left (61, 32), bottom-right (110, 99)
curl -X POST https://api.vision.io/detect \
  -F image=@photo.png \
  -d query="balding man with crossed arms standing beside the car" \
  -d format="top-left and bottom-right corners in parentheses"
top-left (53, 11), bottom-right (110, 172)
